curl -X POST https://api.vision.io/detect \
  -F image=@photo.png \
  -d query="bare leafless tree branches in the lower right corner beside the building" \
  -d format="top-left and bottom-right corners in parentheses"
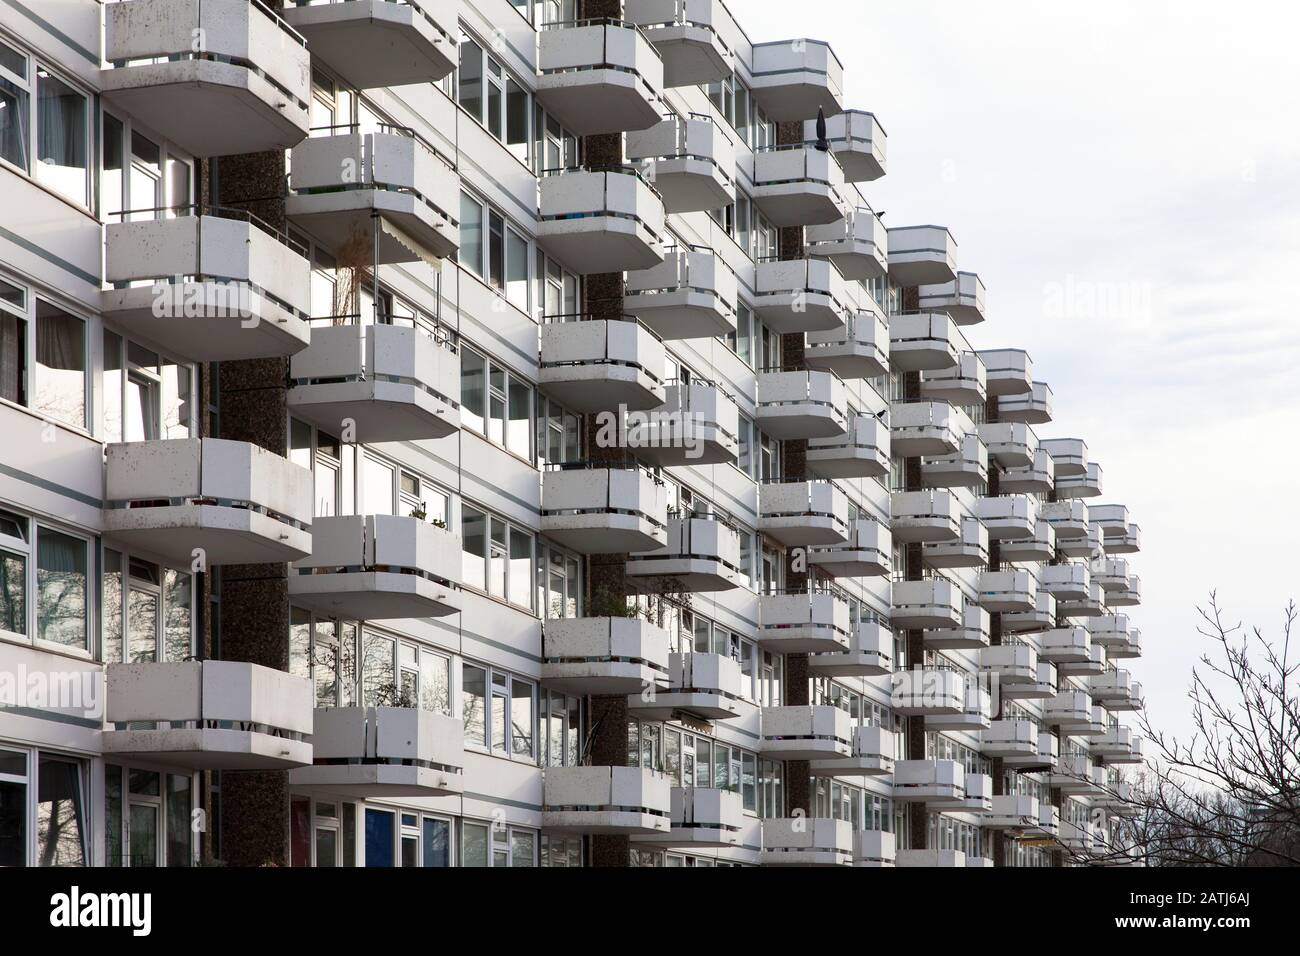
top-left (1093, 592), bottom-right (1300, 866)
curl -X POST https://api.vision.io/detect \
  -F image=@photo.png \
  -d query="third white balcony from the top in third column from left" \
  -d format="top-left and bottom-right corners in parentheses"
top-left (538, 319), bottom-right (666, 414)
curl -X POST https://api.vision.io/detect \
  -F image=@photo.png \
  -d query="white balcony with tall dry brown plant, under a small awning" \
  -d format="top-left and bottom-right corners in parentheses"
top-left (289, 321), bottom-right (460, 442)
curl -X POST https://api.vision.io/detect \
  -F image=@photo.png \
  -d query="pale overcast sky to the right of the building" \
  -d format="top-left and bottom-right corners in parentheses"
top-left (728, 0), bottom-right (1300, 735)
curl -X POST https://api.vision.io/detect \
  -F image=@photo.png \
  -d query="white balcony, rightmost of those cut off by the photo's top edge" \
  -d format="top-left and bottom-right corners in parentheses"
top-left (623, 0), bottom-right (732, 87)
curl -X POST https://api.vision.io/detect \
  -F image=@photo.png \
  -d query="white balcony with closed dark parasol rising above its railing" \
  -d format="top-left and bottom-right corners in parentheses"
top-left (753, 143), bottom-right (844, 229)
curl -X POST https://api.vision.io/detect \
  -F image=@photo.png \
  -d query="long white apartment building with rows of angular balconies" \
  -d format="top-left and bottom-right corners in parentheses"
top-left (0, 0), bottom-right (1143, 866)
